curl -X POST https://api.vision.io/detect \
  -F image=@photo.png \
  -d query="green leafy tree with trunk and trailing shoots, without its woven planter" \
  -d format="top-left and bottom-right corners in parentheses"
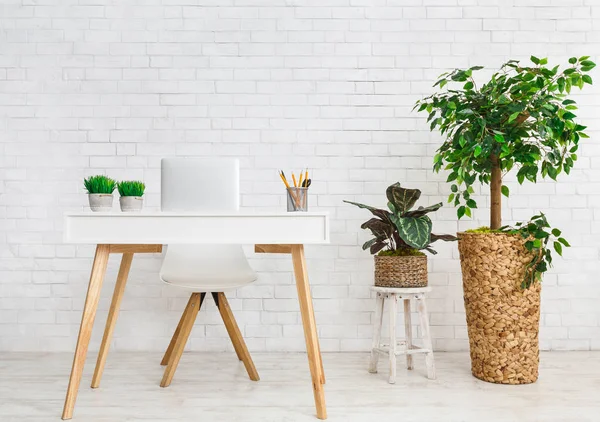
top-left (415, 56), bottom-right (596, 286)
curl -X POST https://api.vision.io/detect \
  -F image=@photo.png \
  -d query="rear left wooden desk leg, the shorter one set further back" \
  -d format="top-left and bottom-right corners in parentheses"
top-left (92, 253), bottom-right (133, 388)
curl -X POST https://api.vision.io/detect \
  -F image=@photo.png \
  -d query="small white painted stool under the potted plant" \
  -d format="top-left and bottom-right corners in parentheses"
top-left (369, 286), bottom-right (435, 384)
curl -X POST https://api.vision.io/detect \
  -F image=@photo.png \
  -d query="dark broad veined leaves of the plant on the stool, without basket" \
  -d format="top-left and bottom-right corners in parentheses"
top-left (344, 183), bottom-right (456, 254)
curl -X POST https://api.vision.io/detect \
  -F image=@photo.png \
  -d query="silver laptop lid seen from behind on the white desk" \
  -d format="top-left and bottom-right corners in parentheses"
top-left (160, 158), bottom-right (240, 212)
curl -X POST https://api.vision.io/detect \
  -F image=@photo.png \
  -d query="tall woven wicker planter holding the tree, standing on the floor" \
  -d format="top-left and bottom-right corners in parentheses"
top-left (458, 233), bottom-right (541, 384)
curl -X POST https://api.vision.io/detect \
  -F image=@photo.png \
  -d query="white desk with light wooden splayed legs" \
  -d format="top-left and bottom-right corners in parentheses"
top-left (62, 212), bottom-right (329, 419)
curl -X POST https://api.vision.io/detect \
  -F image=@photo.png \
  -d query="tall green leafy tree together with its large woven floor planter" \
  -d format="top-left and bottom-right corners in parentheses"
top-left (415, 56), bottom-right (595, 384)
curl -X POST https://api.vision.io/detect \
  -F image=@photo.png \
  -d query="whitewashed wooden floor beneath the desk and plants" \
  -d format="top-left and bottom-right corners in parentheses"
top-left (0, 352), bottom-right (600, 422)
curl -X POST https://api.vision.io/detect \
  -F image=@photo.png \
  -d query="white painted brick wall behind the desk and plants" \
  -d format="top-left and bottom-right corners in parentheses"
top-left (0, 0), bottom-right (600, 351)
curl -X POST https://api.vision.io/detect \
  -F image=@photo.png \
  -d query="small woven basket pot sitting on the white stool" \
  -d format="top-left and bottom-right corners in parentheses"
top-left (375, 255), bottom-right (427, 287)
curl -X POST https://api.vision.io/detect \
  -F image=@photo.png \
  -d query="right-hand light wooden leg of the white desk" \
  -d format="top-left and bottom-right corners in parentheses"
top-left (292, 245), bottom-right (327, 419)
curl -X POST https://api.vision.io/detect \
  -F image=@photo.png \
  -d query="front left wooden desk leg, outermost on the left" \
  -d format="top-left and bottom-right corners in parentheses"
top-left (62, 245), bottom-right (110, 419)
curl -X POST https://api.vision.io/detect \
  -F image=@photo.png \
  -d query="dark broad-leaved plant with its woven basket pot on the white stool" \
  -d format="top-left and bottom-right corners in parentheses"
top-left (344, 183), bottom-right (456, 287)
